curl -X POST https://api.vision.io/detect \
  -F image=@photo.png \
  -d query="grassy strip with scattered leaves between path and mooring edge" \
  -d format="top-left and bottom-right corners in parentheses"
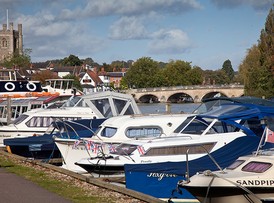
top-left (0, 156), bottom-right (130, 203)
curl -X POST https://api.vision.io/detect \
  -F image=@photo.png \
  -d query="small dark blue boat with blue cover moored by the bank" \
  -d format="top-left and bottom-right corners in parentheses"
top-left (4, 118), bottom-right (106, 159)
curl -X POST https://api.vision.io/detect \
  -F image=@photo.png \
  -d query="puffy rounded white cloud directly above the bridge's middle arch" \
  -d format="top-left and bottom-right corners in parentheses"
top-left (149, 29), bottom-right (191, 54)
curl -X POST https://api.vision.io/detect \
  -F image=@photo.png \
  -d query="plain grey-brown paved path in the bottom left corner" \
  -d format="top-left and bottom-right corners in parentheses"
top-left (0, 168), bottom-right (71, 203)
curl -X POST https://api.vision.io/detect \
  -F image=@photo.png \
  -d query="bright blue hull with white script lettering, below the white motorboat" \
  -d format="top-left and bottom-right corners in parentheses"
top-left (125, 136), bottom-right (274, 200)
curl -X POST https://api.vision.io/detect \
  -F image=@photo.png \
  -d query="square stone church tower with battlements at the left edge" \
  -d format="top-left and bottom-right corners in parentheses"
top-left (0, 23), bottom-right (23, 61)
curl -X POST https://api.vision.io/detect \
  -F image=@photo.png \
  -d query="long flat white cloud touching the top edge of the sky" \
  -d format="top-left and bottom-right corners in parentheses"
top-left (59, 0), bottom-right (202, 20)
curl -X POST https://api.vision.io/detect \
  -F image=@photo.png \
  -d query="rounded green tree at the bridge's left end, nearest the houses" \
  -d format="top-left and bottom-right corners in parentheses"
top-left (125, 57), bottom-right (160, 88)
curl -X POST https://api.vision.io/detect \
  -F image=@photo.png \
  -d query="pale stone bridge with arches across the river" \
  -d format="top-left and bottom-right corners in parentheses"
top-left (127, 85), bottom-right (244, 103)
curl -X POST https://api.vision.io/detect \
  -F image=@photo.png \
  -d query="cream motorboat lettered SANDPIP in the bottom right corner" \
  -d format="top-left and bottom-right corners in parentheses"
top-left (178, 146), bottom-right (274, 203)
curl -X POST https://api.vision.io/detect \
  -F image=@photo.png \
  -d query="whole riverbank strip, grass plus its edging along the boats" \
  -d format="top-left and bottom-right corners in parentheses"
top-left (0, 147), bottom-right (163, 203)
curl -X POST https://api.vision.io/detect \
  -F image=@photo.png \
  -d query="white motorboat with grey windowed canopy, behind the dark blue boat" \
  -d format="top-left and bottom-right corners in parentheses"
top-left (0, 91), bottom-right (140, 146)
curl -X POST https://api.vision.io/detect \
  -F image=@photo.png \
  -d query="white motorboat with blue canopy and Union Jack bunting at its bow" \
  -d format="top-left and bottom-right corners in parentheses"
top-left (76, 104), bottom-right (274, 173)
